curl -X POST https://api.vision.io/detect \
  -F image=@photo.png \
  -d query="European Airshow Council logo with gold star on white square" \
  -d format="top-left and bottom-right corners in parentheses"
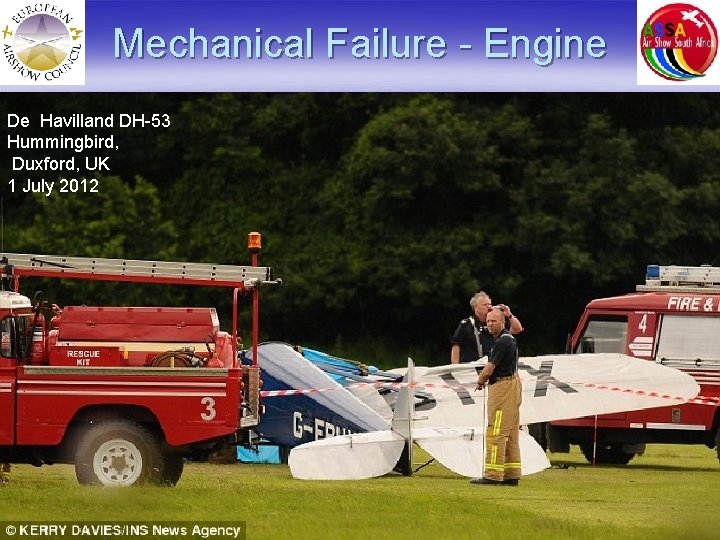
top-left (0, 0), bottom-right (85, 85)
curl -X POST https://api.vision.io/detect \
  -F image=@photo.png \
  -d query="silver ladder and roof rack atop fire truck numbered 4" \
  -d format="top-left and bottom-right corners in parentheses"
top-left (637, 264), bottom-right (720, 293)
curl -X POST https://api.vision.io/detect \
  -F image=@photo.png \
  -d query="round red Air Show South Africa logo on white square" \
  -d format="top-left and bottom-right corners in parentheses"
top-left (637, 0), bottom-right (720, 85)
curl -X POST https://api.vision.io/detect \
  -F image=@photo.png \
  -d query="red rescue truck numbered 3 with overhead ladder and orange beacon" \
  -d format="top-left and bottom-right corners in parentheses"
top-left (0, 233), bottom-right (279, 485)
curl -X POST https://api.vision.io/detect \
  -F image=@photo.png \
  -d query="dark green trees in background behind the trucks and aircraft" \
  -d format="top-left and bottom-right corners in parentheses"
top-left (0, 93), bottom-right (720, 366)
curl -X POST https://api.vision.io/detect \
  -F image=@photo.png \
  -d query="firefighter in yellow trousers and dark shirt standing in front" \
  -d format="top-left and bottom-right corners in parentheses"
top-left (470, 309), bottom-right (522, 486)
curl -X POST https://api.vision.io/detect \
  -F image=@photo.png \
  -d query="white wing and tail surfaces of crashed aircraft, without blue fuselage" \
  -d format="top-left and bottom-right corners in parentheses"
top-left (288, 354), bottom-right (700, 480)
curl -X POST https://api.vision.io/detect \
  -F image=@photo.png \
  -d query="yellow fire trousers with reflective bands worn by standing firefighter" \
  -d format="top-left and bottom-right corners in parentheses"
top-left (484, 374), bottom-right (522, 480)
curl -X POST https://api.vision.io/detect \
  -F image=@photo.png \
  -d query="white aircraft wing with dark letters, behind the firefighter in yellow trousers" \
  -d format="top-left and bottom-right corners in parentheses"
top-left (402, 354), bottom-right (700, 427)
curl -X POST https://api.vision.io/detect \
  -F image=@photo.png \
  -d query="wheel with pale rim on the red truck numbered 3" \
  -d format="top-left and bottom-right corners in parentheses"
top-left (75, 420), bottom-right (163, 486)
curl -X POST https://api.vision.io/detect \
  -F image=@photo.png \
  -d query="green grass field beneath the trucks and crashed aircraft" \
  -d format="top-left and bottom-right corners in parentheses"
top-left (0, 445), bottom-right (720, 540)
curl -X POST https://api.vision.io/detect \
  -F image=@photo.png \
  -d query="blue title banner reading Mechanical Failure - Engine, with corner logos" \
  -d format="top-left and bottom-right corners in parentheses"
top-left (0, 0), bottom-right (720, 92)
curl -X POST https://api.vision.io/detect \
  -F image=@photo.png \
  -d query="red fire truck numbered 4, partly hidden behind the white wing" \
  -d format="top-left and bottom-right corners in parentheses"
top-left (544, 265), bottom-right (720, 464)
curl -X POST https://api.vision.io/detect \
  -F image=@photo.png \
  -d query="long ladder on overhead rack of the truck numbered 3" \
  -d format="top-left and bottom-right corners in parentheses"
top-left (0, 253), bottom-right (275, 288)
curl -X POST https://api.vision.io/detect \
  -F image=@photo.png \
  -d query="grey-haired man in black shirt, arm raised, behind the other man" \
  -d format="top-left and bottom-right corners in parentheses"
top-left (450, 291), bottom-right (523, 364)
